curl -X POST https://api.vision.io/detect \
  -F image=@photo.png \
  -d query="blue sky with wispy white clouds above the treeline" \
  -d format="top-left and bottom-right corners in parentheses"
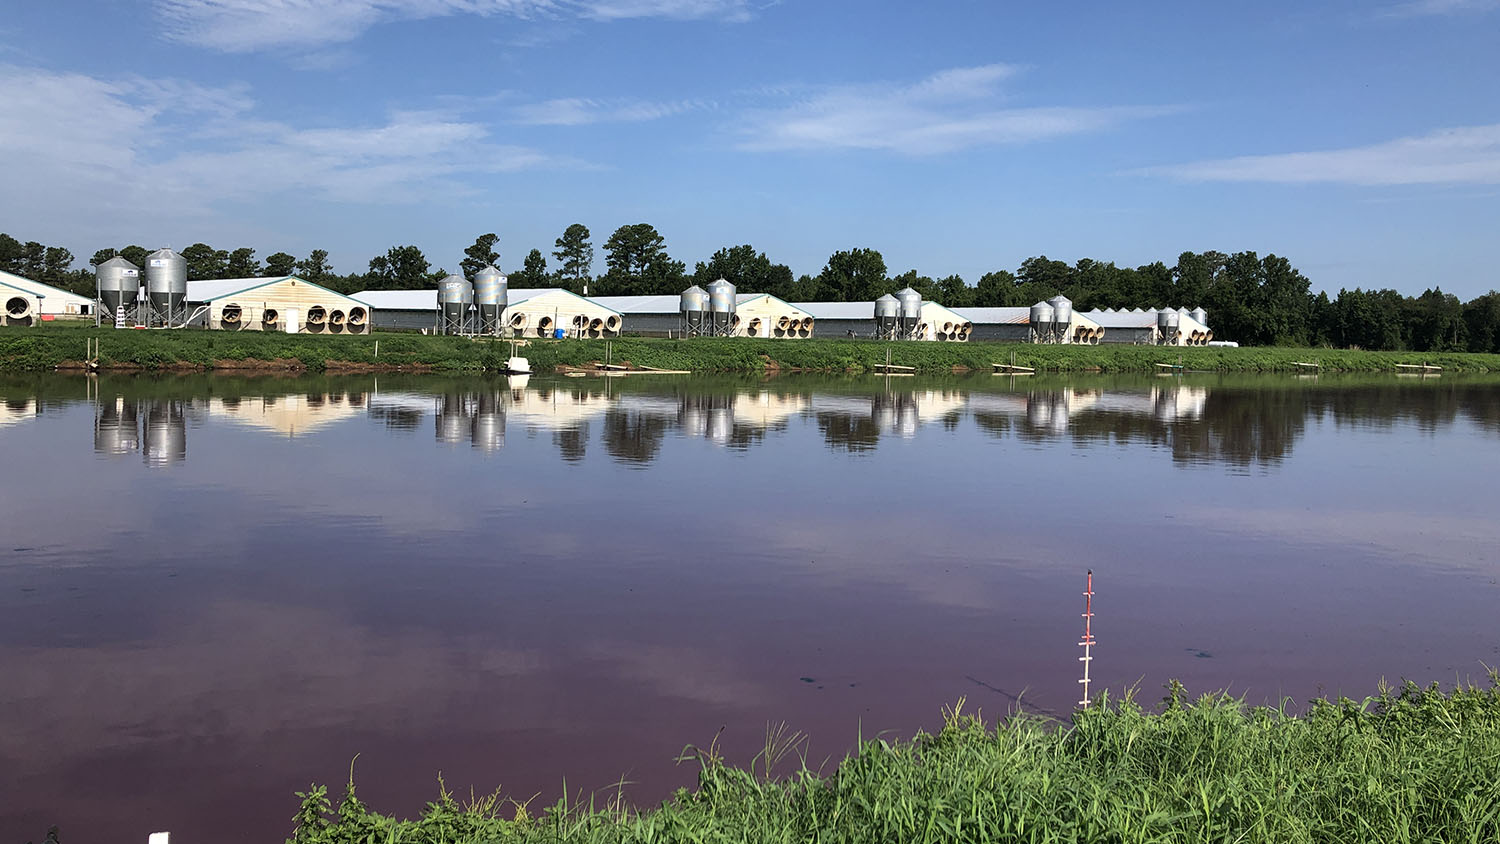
top-left (0, 0), bottom-right (1500, 298)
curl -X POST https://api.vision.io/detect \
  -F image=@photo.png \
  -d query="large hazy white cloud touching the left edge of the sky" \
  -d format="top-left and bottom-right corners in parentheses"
top-left (0, 64), bottom-right (579, 233)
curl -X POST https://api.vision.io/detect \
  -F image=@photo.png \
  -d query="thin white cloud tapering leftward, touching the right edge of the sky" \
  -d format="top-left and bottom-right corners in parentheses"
top-left (1142, 123), bottom-right (1500, 184)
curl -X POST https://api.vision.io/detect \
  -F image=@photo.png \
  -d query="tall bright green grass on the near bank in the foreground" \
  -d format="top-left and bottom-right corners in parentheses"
top-left (291, 675), bottom-right (1500, 844)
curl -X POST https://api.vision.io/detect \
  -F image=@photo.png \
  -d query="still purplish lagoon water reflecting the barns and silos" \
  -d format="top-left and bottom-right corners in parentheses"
top-left (0, 376), bottom-right (1500, 841)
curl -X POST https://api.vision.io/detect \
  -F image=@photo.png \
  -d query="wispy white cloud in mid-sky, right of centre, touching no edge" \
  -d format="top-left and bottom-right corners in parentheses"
top-left (740, 64), bottom-right (1176, 156)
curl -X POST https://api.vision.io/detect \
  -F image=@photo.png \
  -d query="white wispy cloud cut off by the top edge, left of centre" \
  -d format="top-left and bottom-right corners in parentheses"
top-left (156, 0), bottom-right (752, 52)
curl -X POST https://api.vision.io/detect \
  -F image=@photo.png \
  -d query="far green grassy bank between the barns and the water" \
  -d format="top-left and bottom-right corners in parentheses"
top-left (0, 325), bottom-right (1500, 373)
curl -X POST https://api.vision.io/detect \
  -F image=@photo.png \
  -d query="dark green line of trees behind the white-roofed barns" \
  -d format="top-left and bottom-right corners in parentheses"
top-left (0, 223), bottom-right (1500, 352)
